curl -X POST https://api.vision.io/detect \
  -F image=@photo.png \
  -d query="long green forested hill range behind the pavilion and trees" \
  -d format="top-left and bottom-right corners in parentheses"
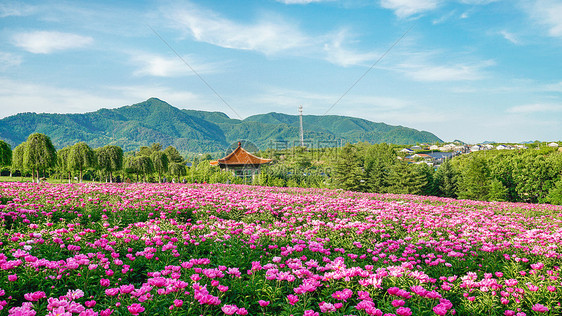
top-left (0, 98), bottom-right (441, 153)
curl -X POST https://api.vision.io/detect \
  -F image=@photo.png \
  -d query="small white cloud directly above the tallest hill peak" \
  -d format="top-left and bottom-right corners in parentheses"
top-left (133, 54), bottom-right (223, 77)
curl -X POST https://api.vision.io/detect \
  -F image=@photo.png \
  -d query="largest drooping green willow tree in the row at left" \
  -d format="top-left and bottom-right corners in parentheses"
top-left (23, 133), bottom-right (57, 183)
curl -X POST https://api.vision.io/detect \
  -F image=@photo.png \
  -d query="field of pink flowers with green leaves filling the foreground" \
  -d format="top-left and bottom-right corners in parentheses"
top-left (0, 183), bottom-right (562, 316)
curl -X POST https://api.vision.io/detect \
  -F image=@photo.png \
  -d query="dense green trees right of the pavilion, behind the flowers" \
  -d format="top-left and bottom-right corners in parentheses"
top-left (256, 143), bottom-right (562, 204)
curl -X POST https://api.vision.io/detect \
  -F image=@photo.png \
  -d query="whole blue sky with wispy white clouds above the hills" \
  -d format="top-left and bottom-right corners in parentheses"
top-left (0, 0), bottom-right (562, 143)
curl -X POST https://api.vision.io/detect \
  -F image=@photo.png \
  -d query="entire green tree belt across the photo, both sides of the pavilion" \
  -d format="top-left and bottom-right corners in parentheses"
top-left (0, 133), bottom-right (562, 204)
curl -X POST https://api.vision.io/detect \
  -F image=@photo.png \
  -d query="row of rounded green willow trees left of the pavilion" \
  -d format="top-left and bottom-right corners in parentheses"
top-left (0, 133), bottom-right (192, 182)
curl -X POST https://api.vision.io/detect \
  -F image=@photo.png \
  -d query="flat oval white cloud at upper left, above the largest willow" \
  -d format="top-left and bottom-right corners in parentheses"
top-left (13, 31), bottom-right (94, 54)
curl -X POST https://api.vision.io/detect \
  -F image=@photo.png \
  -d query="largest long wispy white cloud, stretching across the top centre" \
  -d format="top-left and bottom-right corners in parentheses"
top-left (165, 4), bottom-right (376, 66)
